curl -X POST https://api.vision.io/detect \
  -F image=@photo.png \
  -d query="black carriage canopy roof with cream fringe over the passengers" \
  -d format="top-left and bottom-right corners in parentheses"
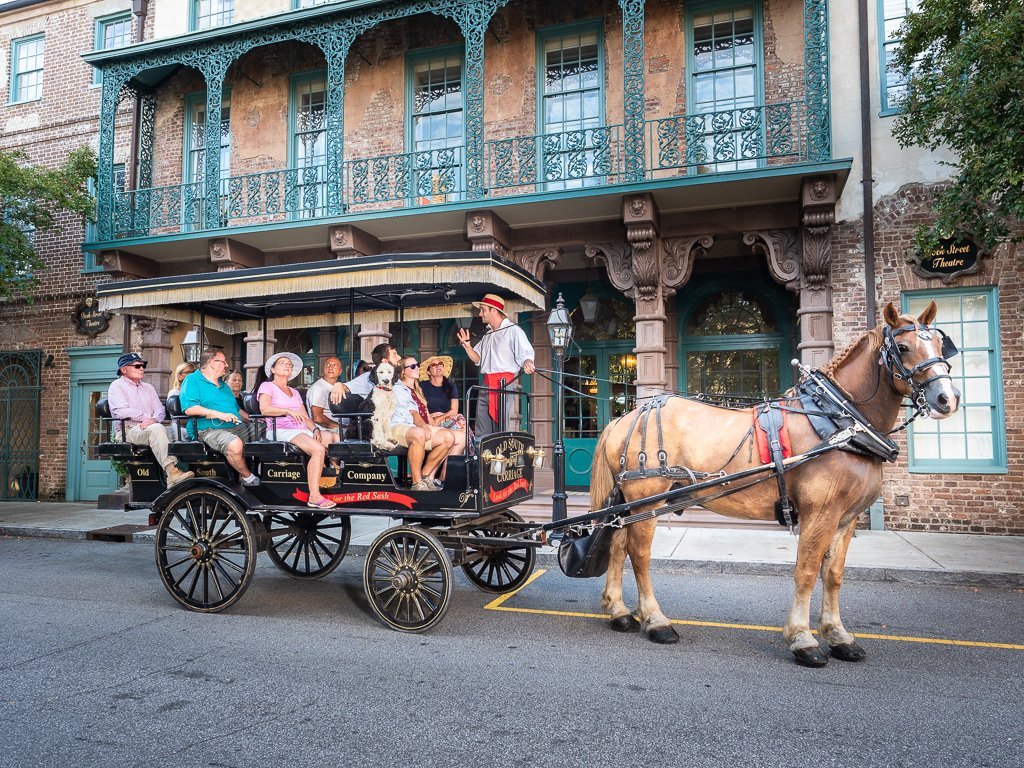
top-left (96, 251), bottom-right (545, 334)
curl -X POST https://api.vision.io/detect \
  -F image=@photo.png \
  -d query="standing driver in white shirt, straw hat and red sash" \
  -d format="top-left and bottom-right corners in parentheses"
top-left (459, 293), bottom-right (536, 435)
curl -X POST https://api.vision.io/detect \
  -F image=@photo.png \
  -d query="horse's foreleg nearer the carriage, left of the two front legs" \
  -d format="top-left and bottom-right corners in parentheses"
top-left (782, 512), bottom-right (830, 667)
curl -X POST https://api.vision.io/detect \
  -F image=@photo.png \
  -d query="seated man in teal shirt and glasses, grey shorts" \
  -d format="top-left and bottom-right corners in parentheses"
top-left (180, 348), bottom-right (259, 485)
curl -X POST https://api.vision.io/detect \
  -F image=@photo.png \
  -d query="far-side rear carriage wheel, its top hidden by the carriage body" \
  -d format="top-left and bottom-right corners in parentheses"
top-left (266, 512), bottom-right (352, 579)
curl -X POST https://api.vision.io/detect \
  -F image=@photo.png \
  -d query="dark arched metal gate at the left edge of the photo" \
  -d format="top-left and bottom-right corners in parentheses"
top-left (0, 349), bottom-right (43, 501)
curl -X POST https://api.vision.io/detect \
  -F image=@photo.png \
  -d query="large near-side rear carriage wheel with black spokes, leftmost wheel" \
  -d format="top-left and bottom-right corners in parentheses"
top-left (157, 488), bottom-right (256, 613)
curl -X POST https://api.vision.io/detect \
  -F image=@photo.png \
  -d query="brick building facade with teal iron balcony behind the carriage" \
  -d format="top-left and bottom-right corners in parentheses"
top-left (0, 0), bottom-right (1024, 534)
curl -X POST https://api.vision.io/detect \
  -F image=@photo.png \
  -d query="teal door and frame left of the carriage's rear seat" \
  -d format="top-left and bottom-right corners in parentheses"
top-left (66, 346), bottom-right (121, 502)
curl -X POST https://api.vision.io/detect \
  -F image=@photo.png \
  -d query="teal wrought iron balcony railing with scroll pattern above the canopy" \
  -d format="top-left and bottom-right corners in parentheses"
top-left (101, 101), bottom-right (807, 240)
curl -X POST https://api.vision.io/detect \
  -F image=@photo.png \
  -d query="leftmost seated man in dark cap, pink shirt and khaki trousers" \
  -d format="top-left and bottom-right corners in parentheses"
top-left (106, 352), bottom-right (194, 487)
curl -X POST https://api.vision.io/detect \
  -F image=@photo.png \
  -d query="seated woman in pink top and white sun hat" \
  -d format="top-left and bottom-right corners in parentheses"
top-left (256, 352), bottom-right (338, 509)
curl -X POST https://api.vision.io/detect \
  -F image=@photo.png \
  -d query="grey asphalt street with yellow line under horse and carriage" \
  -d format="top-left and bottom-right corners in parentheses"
top-left (0, 538), bottom-right (1024, 768)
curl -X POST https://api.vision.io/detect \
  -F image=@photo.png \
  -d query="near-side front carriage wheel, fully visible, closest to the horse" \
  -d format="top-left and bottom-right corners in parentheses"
top-left (362, 525), bottom-right (452, 632)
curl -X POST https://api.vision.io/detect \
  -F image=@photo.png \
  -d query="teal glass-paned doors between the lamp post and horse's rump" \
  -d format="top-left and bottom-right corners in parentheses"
top-left (563, 342), bottom-right (637, 487)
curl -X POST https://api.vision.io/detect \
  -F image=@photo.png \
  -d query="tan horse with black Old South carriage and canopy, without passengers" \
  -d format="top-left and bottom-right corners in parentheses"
top-left (98, 252), bottom-right (959, 667)
